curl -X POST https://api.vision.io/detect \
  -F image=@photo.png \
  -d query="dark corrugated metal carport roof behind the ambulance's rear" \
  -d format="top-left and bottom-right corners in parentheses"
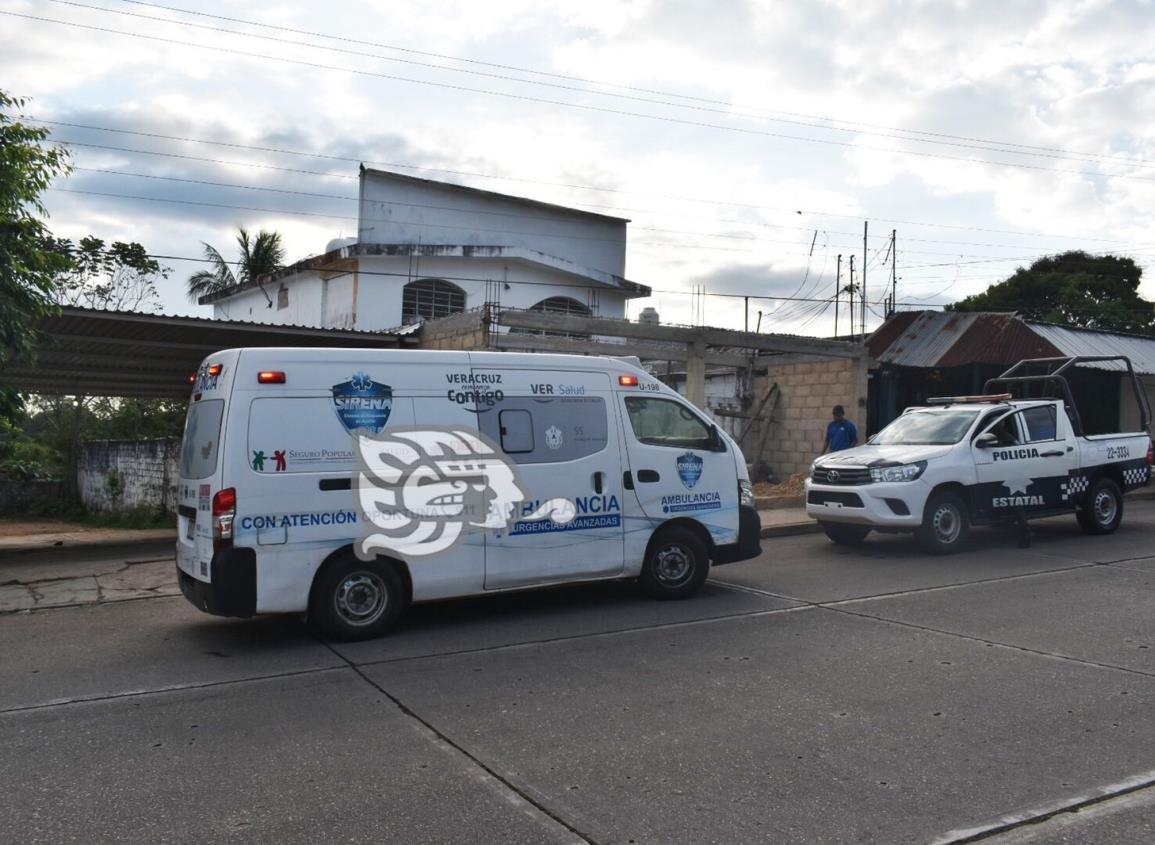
top-left (0, 307), bottom-right (418, 399)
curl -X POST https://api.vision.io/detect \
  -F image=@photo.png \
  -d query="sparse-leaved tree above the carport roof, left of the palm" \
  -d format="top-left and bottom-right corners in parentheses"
top-left (54, 237), bottom-right (171, 312)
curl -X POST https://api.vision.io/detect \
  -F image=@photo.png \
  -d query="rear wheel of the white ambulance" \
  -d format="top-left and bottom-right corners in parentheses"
top-left (308, 554), bottom-right (405, 640)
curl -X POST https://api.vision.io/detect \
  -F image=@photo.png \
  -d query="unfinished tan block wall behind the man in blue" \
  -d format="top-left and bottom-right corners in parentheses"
top-left (743, 356), bottom-right (869, 479)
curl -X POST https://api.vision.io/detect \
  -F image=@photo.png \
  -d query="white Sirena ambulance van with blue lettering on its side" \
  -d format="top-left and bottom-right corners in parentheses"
top-left (177, 347), bottom-right (761, 638)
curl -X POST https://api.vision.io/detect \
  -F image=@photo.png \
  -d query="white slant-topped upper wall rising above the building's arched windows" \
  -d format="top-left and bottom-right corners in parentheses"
top-left (358, 171), bottom-right (626, 276)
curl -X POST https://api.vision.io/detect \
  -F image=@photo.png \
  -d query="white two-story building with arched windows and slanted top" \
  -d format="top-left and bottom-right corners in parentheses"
top-left (200, 167), bottom-right (650, 331)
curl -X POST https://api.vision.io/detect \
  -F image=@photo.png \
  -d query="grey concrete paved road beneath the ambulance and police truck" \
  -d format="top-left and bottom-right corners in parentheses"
top-left (0, 502), bottom-right (1155, 843)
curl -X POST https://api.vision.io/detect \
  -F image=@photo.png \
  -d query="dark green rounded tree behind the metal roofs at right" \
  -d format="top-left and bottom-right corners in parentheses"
top-left (946, 250), bottom-right (1155, 335)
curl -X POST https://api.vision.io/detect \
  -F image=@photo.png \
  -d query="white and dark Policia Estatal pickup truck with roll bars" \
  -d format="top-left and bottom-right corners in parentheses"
top-left (806, 357), bottom-right (1153, 554)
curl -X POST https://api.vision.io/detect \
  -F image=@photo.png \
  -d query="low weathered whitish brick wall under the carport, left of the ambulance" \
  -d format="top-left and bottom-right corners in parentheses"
top-left (76, 438), bottom-right (180, 513)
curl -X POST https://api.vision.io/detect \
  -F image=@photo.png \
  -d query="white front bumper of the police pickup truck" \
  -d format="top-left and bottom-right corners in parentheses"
top-left (806, 479), bottom-right (931, 529)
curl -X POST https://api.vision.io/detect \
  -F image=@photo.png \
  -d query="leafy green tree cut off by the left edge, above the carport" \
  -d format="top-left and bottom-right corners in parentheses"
top-left (0, 90), bottom-right (70, 419)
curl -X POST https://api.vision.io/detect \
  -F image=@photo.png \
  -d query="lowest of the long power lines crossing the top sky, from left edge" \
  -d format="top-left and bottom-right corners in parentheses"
top-left (11, 9), bottom-right (1155, 187)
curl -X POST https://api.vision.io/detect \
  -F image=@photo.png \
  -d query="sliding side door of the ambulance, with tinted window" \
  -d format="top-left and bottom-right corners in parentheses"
top-left (474, 367), bottom-right (624, 590)
